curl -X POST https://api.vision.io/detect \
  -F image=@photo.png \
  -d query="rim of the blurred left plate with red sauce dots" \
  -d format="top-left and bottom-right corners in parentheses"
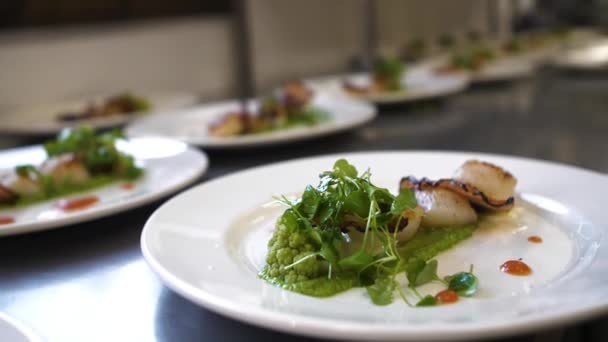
top-left (0, 139), bottom-right (209, 238)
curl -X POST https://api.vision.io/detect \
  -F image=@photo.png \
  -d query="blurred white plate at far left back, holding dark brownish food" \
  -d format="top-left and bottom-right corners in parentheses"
top-left (0, 92), bottom-right (198, 135)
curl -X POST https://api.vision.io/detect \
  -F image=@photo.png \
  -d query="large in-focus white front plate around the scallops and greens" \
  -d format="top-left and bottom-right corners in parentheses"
top-left (141, 152), bottom-right (608, 341)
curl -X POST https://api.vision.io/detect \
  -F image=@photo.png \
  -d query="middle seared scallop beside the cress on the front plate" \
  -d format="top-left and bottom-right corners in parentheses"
top-left (416, 188), bottom-right (477, 227)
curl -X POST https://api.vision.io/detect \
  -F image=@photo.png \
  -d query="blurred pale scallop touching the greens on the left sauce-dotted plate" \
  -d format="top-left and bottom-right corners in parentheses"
top-left (40, 154), bottom-right (91, 185)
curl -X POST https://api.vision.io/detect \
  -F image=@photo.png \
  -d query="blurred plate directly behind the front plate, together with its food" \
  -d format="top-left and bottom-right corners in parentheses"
top-left (126, 90), bottom-right (376, 148)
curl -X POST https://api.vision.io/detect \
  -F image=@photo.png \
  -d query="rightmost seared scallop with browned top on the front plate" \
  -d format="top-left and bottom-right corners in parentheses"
top-left (454, 160), bottom-right (517, 201)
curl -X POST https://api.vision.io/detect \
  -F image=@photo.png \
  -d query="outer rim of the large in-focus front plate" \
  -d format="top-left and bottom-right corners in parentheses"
top-left (140, 150), bottom-right (608, 341)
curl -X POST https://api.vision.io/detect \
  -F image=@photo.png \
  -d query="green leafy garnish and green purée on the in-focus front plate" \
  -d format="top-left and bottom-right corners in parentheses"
top-left (260, 159), bottom-right (482, 306)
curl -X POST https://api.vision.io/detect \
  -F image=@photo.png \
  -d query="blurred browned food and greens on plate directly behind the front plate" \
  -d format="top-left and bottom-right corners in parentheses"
top-left (209, 81), bottom-right (331, 137)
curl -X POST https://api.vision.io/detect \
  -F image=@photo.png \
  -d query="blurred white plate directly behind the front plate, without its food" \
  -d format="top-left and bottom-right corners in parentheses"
top-left (125, 93), bottom-right (376, 148)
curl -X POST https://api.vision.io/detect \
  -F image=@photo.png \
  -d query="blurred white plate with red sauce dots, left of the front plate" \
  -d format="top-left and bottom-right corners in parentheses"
top-left (0, 137), bottom-right (208, 236)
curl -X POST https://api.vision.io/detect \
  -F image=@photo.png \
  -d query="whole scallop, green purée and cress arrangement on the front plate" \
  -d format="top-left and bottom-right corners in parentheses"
top-left (260, 159), bottom-right (516, 306)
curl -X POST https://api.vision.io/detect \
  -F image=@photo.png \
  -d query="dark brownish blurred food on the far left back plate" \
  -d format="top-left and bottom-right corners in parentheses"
top-left (57, 92), bottom-right (152, 122)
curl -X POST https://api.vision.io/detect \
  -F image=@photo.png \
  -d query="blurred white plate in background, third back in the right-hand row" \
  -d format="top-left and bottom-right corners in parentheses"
top-left (309, 67), bottom-right (470, 104)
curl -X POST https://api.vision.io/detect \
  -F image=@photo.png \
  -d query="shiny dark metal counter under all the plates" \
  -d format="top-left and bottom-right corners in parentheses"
top-left (0, 71), bottom-right (608, 342)
